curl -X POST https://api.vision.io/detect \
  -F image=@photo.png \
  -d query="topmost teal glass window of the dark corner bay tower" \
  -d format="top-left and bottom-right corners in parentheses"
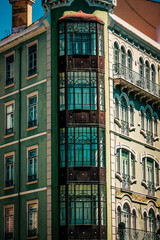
top-left (67, 22), bottom-right (97, 55)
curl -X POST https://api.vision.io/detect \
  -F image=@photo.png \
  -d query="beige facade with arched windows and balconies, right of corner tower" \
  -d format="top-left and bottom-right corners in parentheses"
top-left (109, 12), bottom-right (160, 240)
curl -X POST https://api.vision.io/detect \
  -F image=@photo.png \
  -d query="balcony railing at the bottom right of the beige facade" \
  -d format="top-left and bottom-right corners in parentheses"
top-left (116, 228), bottom-right (159, 240)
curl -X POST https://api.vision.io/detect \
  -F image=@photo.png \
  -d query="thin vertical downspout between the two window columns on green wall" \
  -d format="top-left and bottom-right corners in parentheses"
top-left (18, 47), bottom-right (22, 240)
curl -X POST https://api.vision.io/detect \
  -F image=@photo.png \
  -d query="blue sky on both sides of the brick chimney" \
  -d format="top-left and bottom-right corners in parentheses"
top-left (0, 0), bottom-right (44, 40)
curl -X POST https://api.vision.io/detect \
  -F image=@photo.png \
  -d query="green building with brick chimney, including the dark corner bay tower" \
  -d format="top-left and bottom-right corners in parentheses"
top-left (0, 0), bottom-right (116, 240)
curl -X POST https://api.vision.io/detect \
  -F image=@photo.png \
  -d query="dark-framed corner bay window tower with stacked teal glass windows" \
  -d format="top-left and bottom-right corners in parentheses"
top-left (58, 11), bottom-right (107, 239)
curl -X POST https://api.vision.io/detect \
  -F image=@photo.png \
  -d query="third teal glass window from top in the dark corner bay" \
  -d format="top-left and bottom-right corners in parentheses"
top-left (68, 127), bottom-right (97, 167)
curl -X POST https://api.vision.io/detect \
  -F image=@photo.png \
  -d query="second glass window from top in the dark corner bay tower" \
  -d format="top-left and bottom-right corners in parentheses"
top-left (67, 72), bottom-right (97, 110)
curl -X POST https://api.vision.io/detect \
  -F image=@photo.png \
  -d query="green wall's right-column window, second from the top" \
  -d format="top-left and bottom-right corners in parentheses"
top-left (28, 95), bottom-right (37, 128)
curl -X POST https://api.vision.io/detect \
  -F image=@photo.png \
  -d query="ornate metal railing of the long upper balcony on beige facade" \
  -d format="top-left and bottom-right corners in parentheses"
top-left (113, 63), bottom-right (160, 97)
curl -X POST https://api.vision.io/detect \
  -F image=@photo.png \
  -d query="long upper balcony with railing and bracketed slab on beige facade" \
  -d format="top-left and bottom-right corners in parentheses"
top-left (113, 63), bottom-right (160, 103)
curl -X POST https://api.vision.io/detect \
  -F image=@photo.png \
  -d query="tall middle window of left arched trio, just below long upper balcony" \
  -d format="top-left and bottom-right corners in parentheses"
top-left (121, 97), bottom-right (129, 135)
